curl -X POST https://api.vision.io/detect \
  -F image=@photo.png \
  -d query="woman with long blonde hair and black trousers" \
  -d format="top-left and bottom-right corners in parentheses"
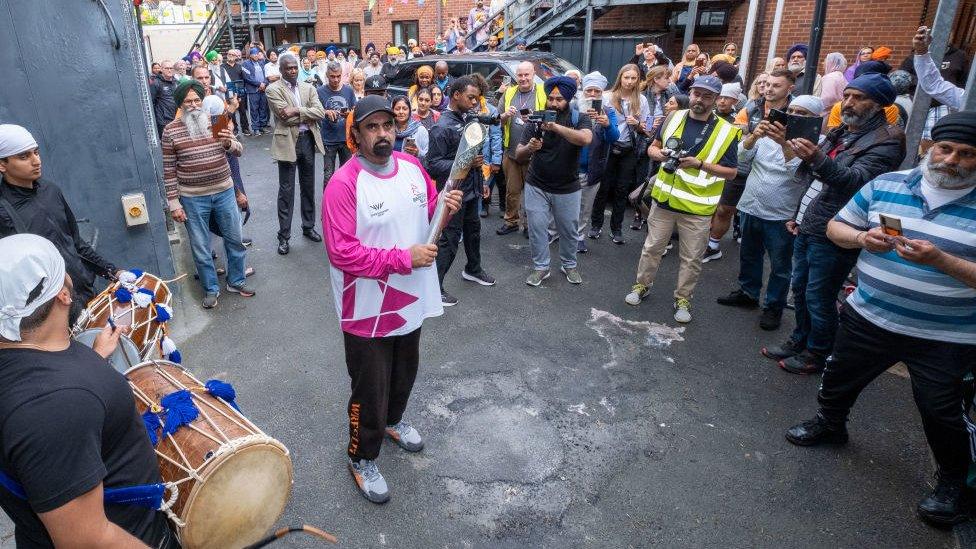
top-left (588, 64), bottom-right (654, 245)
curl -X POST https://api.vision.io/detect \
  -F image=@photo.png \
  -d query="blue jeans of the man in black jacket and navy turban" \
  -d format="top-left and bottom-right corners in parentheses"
top-left (791, 233), bottom-right (860, 357)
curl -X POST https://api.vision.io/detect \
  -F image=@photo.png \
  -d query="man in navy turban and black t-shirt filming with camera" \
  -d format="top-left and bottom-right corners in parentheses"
top-left (515, 76), bottom-right (593, 286)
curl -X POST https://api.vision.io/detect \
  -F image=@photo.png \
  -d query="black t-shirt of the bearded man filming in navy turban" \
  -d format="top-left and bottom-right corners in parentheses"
top-left (522, 109), bottom-right (593, 194)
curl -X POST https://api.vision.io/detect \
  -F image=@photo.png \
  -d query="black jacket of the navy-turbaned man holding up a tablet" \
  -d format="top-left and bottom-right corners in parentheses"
top-left (794, 111), bottom-right (905, 236)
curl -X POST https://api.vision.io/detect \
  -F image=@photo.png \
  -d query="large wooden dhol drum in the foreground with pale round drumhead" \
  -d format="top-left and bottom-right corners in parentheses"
top-left (125, 360), bottom-right (292, 549)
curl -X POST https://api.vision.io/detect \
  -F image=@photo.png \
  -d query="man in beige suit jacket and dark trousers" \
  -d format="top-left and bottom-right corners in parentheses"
top-left (265, 53), bottom-right (325, 255)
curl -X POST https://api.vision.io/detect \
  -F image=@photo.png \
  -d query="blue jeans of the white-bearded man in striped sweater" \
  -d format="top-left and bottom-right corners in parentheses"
top-left (180, 188), bottom-right (245, 294)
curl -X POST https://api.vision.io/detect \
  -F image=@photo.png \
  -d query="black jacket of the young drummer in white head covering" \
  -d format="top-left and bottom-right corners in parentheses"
top-left (0, 179), bottom-right (117, 301)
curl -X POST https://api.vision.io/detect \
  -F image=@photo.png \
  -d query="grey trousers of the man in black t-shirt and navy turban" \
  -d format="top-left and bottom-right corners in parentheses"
top-left (524, 185), bottom-right (581, 271)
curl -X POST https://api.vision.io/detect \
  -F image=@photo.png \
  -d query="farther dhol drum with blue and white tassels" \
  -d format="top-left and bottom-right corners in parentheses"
top-left (74, 272), bottom-right (172, 362)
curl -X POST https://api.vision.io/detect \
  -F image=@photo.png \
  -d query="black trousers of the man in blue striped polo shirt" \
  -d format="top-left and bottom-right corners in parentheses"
top-left (817, 306), bottom-right (976, 479)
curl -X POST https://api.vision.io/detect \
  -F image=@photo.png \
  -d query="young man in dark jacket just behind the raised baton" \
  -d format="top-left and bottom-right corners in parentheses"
top-left (427, 76), bottom-right (495, 307)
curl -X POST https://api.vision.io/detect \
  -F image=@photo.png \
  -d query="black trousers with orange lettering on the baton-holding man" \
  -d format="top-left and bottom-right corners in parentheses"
top-left (342, 328), bottom-right (420, 460)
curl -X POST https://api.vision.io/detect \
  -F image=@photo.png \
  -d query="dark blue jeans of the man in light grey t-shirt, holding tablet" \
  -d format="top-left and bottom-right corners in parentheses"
top-left (739, 212), bottom-right (794, 311)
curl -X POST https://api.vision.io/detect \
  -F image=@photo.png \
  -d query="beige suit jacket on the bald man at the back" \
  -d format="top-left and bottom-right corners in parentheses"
top-left (264, 78), bottom-right (325, 162)
